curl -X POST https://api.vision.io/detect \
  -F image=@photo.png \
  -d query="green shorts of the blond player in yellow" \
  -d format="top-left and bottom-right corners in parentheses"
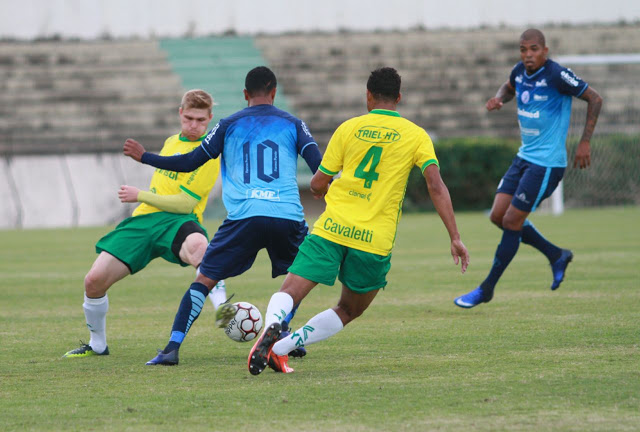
top-left (96, 212), bottom-right (207, 274)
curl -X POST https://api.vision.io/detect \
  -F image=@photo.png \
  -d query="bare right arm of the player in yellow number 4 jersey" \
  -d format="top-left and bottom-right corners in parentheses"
top-left (423, 164), bottom-right (469, 273)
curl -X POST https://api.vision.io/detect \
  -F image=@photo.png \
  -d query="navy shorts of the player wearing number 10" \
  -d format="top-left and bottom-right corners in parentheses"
top-left (200, 216), bottom-right (309, 280)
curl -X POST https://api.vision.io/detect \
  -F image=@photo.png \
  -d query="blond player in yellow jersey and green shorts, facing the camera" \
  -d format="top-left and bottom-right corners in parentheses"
top-left (64, 90), bottom-right (226, 358)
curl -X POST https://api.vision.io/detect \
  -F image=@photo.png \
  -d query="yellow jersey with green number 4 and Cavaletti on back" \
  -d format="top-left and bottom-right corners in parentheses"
top-left (313, 110), bottom-right (438, 256)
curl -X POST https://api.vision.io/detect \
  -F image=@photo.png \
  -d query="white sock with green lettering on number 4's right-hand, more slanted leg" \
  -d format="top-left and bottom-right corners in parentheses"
top-left (273, 309), bottom-right (344, 355)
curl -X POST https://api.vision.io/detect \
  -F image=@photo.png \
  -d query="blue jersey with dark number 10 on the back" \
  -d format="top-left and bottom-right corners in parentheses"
top-left (201, 105), bottom-right (317, 221)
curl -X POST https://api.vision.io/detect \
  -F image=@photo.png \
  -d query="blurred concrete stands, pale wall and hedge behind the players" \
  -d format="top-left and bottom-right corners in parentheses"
top-left (0, 0), bottom-right (640, 229)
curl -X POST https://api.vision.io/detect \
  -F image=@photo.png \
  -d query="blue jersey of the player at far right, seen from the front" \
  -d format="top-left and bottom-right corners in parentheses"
top-left (509, 60), bottom-right (588, 167)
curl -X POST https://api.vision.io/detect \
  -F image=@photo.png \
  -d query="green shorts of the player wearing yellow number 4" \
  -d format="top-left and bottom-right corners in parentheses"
top-left (289, 234), bottom-right (391, 293)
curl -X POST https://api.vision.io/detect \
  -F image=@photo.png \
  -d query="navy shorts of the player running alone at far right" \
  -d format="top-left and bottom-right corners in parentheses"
top-left (496, 156), bottom-right (565, 212)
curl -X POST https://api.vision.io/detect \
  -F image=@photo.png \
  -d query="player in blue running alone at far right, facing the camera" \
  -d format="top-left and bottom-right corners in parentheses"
top-left (454, 29), bottom-right (602, 308)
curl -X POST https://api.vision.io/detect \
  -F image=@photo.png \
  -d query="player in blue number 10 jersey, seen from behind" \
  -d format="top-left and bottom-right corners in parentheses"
top-left (124, 66), bottom-right (321, 365)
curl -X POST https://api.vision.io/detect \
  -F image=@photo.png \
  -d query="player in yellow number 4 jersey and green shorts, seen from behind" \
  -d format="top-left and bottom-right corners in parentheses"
top-left (248, 67), bottom-right (469, 375)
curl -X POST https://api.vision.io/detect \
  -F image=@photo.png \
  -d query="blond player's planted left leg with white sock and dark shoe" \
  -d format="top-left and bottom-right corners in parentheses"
top-left (64, 251), bottom-right (131, 358)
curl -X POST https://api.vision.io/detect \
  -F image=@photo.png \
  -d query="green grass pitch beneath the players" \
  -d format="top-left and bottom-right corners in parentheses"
top-left (0, 207), bottom-right (640, 431)
